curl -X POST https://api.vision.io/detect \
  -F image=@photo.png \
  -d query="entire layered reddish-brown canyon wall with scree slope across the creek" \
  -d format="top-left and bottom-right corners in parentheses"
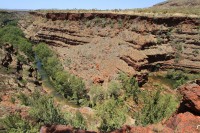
top-left (20, 12), bottom-right (200, 85)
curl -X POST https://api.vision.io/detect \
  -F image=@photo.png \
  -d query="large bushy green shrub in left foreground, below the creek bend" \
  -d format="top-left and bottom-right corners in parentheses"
top-left (29, 91), bottom-right (67, 124)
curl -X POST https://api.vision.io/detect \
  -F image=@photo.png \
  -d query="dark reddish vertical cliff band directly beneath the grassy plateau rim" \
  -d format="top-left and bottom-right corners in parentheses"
top-left (30, 12), bottom-right (199, 26)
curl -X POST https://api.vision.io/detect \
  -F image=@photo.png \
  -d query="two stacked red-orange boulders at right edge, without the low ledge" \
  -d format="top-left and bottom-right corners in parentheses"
top-left (166, 80), bottom-right (200, 133)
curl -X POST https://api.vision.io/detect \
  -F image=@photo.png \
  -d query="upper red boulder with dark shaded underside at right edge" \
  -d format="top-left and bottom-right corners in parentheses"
top-left (178, 83), bottom-right (200, 115)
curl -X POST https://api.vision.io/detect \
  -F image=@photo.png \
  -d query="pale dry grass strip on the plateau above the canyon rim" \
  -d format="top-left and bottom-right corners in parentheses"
top-left (36, 7), bottom-right (200, 18)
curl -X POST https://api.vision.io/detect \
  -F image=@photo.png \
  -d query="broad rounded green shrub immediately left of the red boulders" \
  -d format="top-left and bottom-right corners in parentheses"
top-left (136, 91), bottom-right (179, 126)
